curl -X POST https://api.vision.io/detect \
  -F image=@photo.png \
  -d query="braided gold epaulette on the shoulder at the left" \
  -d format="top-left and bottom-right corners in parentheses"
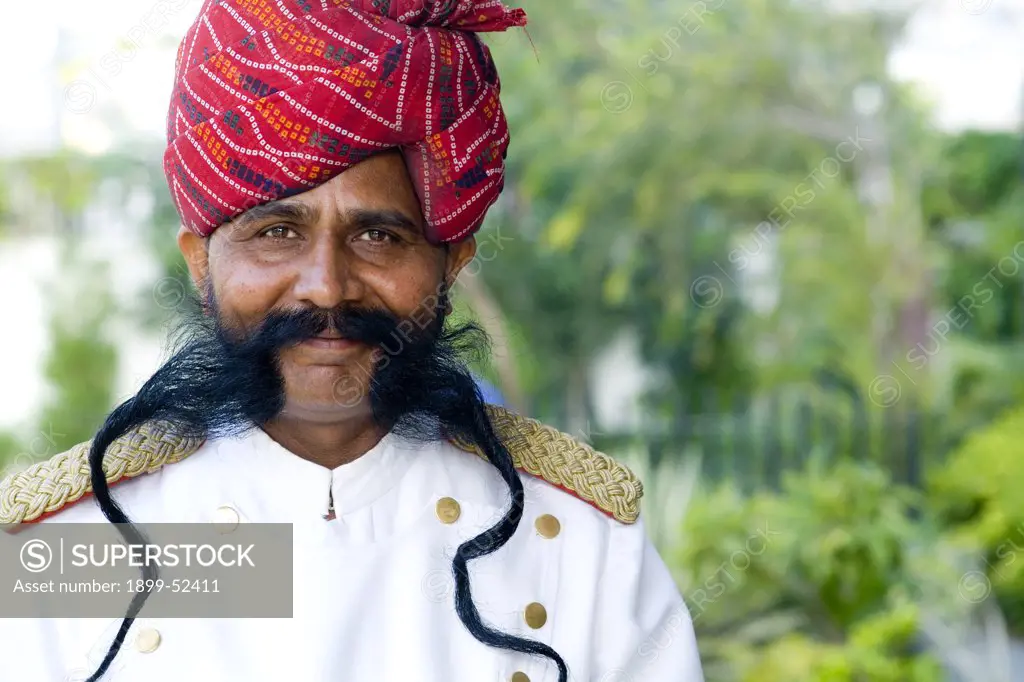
top-left (0, 422), bottom-right (203, 526)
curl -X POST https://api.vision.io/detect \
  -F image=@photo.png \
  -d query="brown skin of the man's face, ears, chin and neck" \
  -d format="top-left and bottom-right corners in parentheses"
top-left (178, 152), bottom-right (476, 469)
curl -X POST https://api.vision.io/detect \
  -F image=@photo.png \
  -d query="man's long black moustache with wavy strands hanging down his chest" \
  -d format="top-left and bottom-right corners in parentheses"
top-left (87, 290), bottom-right (568, 682)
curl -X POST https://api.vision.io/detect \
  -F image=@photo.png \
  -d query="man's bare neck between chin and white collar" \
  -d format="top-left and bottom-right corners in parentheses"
top-left (263, 415), bottom-right (386, 469)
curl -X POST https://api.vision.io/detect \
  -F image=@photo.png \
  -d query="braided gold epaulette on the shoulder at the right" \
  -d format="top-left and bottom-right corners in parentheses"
top-left (453, 406), bottom-right (643, 523)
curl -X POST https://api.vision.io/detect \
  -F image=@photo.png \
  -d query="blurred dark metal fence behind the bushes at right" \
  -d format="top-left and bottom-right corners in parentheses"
top-left (593, 374), bottom-right (983, 492)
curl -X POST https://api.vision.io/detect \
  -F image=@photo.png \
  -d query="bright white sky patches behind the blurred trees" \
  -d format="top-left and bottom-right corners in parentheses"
top-left (0, 0), bottom-right (1024, 428)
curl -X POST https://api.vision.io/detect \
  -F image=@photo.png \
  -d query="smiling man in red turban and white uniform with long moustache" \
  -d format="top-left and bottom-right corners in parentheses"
top-left (0, 0), bottom-right (701, 682)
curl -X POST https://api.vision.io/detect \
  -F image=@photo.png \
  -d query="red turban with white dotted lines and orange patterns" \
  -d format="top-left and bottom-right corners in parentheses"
top-left (164, 0), bottom-right (526, 243)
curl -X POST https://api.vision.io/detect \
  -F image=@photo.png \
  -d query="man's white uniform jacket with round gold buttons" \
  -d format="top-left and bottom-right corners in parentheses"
top-left (0, 409), bottom-right (702, 682)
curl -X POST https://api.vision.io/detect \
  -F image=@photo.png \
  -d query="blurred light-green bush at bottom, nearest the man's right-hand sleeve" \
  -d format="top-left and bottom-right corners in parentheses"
top-left (673, 465), bottom-right (955, 682)
